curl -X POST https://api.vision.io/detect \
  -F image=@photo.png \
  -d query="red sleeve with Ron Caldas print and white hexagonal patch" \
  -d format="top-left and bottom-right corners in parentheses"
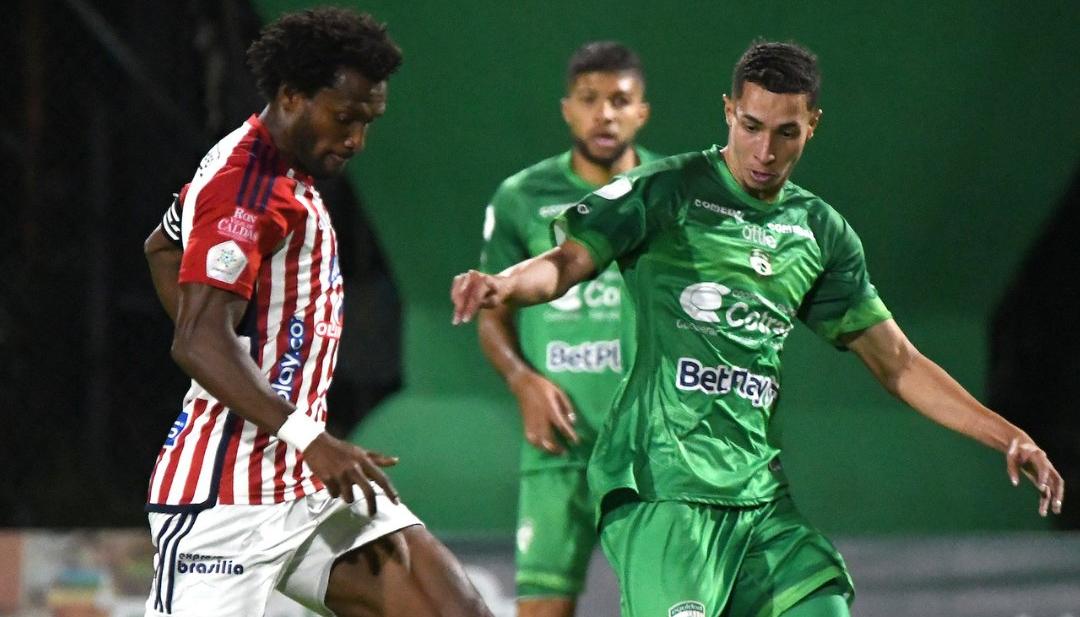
top-left (179, 172), bottom-right (297, 298)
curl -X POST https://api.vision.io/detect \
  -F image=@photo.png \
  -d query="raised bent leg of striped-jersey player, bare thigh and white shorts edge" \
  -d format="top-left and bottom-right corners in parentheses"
top-left (278, 488), bottom-right (490, 617)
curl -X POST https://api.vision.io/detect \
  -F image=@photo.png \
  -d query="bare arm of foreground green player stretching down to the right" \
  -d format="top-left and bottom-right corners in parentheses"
top-left (847, 320), bottom-right (1065, 515)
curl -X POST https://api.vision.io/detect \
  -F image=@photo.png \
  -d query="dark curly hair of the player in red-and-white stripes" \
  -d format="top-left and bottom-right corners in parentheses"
top-left (247, 6), bottom-right (402, 100)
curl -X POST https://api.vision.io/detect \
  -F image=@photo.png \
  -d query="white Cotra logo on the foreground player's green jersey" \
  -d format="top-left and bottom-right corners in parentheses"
top-left (675, 285), bottom-right (793, 336)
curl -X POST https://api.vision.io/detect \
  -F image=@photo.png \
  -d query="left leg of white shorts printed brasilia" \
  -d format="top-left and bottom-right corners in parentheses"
top-left (146, 501), bottom-right (313, 617)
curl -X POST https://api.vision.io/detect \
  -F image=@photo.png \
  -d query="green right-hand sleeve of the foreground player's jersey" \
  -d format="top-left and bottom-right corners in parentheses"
top-left (798, 209), bottom-right (892, 349)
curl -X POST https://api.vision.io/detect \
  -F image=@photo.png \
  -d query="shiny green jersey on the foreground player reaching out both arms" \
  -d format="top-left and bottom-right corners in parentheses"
top-left (556, 147), bottom-right (890, 506)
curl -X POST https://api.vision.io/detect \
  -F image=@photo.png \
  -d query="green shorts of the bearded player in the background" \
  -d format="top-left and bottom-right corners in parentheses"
top-left (514, 468), bottom-right (596, 599)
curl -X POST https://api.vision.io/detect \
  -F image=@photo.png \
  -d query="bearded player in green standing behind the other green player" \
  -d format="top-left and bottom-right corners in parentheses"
top-left (478, 41), bottom-right (656, 617)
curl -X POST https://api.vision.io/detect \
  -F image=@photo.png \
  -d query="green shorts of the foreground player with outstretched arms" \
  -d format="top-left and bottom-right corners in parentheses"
top-left (600, 492), bottom-right (854, 617)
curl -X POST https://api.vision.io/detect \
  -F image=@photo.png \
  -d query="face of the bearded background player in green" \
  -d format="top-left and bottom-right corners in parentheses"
top-left (563, 71), bottom-right (649, 167)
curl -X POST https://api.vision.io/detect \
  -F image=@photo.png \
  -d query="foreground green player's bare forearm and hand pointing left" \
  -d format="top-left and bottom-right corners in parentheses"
top-left (450, 240), bottom-right (596, 325)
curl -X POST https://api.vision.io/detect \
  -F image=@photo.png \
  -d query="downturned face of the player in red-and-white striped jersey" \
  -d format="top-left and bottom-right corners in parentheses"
top-left (286, 69), bottom-right (387, 178)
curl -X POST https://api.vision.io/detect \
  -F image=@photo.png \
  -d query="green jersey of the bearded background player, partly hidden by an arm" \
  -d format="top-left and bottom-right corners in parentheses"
top-left (481, 148), bottom-right (657, 471)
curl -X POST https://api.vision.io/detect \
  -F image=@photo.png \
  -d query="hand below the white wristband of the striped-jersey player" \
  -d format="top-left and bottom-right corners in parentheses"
top-left (303, 432), bottom-right (397, 517)
